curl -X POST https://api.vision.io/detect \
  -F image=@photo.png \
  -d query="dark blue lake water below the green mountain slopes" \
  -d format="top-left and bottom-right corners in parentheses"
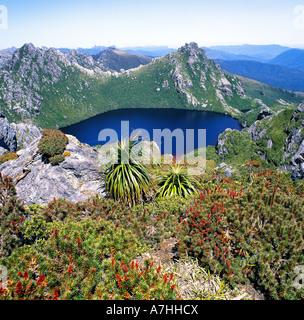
top-left (61, 109), bottom-right (241, 155)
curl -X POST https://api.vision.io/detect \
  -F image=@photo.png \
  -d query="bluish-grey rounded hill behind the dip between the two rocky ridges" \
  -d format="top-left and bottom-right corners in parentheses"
top-left (93, 48), bottom-right (152, 72)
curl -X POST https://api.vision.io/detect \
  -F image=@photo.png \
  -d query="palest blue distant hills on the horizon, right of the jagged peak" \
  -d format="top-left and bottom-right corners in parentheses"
top-left (209, 44), bottom-right (290, 62)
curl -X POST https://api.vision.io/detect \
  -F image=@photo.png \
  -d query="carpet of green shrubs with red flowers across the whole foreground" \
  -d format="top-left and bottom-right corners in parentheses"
top-left (0, 162), bottom-right (304, 300)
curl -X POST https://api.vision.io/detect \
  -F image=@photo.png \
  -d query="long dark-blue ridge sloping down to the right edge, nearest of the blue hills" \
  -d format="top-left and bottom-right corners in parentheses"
top-left (216, 60), bottom-right (304, 92)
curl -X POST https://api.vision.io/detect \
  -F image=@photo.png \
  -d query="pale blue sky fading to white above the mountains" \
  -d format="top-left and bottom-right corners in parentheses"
top-left (0, 0), bottom-right (304, 49)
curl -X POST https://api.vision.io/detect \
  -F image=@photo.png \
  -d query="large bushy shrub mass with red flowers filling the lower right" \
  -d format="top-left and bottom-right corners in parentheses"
top-left (179, 170), bottom-right (304, 299)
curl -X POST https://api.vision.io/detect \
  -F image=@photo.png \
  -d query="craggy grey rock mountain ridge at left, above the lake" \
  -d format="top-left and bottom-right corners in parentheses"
top-left (0, 43), bottom-right (112, 119)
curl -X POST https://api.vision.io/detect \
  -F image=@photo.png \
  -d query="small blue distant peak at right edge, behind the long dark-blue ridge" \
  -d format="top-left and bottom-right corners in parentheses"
top-left (269, 49), bottom-right (304, 71)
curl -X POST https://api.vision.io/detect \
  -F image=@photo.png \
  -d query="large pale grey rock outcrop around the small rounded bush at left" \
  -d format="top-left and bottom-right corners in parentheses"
top-left (0, 135), bottom-right (104, 205)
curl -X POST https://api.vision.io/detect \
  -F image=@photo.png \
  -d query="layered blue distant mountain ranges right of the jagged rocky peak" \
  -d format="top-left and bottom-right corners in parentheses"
top-left (204, 45), bottom-right (304, 92)
